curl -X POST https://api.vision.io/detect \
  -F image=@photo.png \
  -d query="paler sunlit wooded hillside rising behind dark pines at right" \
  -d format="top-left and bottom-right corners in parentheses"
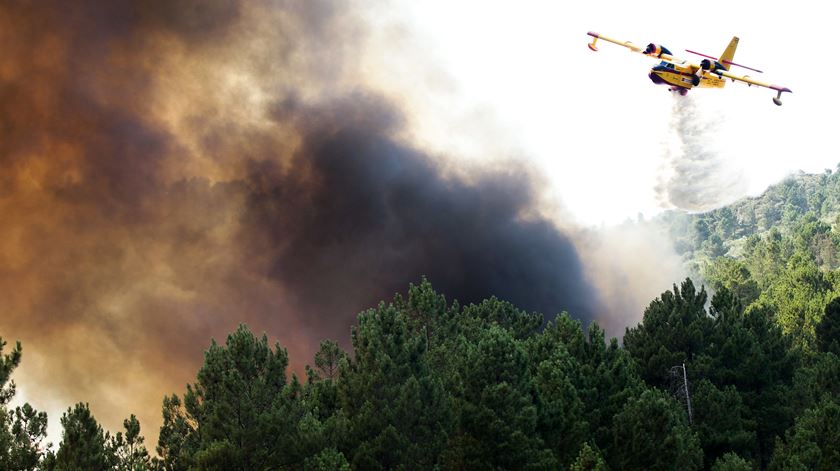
top-left (657, 170), bottom-right (840, 352)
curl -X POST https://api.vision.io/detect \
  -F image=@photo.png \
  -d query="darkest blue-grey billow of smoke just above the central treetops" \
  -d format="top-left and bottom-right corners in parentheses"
top-left (247, 96), bottom-right (594, 340)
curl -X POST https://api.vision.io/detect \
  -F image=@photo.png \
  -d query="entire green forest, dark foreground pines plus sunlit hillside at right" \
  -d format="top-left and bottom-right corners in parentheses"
top-left (0, 172), bottom-right (840, 471)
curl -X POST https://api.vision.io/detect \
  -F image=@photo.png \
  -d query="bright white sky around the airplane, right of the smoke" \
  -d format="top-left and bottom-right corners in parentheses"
top-left (360, 0), bottom-right (840, 224)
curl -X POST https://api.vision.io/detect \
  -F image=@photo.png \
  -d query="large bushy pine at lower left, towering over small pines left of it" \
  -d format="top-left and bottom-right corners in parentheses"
top-left (158, 325), bottom-right (307, 470)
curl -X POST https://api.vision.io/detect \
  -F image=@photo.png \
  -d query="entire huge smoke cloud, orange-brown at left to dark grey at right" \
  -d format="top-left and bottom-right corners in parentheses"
top-left (0, 0), bottom-right (598, 441)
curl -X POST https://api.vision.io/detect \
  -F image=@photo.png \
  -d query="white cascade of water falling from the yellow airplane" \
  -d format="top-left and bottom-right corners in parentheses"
top-left (656, 93), bottom-right (747, 212)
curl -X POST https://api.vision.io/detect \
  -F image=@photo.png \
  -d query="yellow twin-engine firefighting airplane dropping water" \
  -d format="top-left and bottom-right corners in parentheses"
top-left (587, 31), bottom-right (793, 106)
